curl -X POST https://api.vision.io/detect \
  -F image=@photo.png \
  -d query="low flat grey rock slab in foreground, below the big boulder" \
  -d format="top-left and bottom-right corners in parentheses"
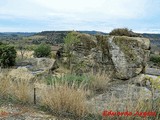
top-left (88, 82), bottom-right (152, 113)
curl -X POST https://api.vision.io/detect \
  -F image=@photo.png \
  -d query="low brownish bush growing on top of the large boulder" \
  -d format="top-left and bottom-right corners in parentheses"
top-left (109, 28), bottom-right (141, 37)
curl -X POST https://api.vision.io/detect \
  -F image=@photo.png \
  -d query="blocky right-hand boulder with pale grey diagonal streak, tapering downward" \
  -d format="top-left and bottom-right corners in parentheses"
top-left (108, 36), bottom-right (150, 79)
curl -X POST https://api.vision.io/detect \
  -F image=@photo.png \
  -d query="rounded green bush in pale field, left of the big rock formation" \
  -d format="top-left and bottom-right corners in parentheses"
top-left (34, 44), bottom-right (51, 58)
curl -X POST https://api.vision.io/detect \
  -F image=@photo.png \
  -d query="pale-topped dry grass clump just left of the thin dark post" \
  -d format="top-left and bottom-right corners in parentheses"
top-left (8, 68), bottom-right (34, 103)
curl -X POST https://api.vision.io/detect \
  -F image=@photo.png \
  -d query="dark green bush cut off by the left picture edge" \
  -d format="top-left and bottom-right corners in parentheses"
top-left (0, 43), bottom-right (16, 67)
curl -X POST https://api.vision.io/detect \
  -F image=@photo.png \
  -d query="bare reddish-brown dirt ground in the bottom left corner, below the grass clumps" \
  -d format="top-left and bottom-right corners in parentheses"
top-left (0, 104), bottom-right (69, 120)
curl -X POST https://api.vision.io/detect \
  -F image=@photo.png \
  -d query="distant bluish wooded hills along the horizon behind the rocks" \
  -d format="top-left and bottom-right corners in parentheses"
top-left (0, 30), bottom-right (160, 47)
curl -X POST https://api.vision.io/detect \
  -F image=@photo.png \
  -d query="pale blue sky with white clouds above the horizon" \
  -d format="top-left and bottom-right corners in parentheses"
top-left (0, 0), bottom-right (160, 33)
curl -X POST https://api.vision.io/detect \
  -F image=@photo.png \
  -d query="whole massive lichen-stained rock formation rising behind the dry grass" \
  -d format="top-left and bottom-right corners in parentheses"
top-left (53, 34), bottom-right (150, 80)
